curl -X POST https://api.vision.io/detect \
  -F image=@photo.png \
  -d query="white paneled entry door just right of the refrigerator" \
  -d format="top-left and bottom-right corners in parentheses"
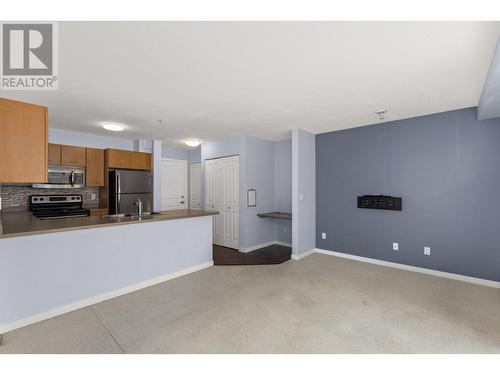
top-left (161, 159), bottom-right (187, 211)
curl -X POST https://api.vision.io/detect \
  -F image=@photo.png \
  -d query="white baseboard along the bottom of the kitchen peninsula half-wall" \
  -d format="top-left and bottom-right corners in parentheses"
top-left (0, 261), bottom-right (214, 334)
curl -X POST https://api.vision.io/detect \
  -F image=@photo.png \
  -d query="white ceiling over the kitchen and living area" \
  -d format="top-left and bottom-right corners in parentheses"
top-left (1, 22), bottom-right (500, 146)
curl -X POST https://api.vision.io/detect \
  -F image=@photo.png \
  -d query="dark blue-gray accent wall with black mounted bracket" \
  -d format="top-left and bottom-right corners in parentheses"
top-left (316, 108), bottom-right (500, 281)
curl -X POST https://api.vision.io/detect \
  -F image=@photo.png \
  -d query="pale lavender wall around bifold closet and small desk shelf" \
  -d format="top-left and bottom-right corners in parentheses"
top-left (200, 136), bottom-right (292, 248)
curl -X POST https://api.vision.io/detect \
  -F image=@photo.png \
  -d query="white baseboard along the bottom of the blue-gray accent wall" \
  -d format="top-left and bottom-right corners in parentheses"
top-left (313, 249), bottom-right (500, 288)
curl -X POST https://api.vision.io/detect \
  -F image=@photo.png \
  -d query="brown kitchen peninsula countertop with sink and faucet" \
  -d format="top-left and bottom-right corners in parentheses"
top-left (0, 210), bottom-right (218, 239)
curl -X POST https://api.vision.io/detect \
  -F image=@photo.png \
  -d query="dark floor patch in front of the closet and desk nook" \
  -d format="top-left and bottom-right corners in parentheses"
top-left (213, 245), bottom-right (292, 266)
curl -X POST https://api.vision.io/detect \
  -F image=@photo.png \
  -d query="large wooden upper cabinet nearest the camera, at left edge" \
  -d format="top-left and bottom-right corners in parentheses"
top-left (0, 98), bottom-right (48, 183)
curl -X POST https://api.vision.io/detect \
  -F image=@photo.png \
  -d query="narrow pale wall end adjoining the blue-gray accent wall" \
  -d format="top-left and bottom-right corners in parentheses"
top-left (292, 129), bottom-right (316, 256)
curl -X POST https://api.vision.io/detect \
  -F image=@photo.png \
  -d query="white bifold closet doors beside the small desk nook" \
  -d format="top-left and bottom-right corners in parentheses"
top-left (205, 156), bottom-right (240, 249)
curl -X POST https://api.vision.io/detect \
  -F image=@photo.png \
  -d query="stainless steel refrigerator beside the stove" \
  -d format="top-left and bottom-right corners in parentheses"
top-left (108, 169), bottom-right (153, 214)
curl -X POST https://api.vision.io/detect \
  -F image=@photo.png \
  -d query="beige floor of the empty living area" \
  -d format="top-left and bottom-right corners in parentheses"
top-left (0, 254), bottom-right (500, 353)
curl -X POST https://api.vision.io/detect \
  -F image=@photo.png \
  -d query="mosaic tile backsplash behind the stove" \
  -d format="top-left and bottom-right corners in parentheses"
top-left (0, 185), bottom-right (99, 209)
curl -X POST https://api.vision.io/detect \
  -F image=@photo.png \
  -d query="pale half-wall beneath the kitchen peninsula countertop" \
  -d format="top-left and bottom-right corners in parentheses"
top-left (0, 216), bottom-right (212, 333)
